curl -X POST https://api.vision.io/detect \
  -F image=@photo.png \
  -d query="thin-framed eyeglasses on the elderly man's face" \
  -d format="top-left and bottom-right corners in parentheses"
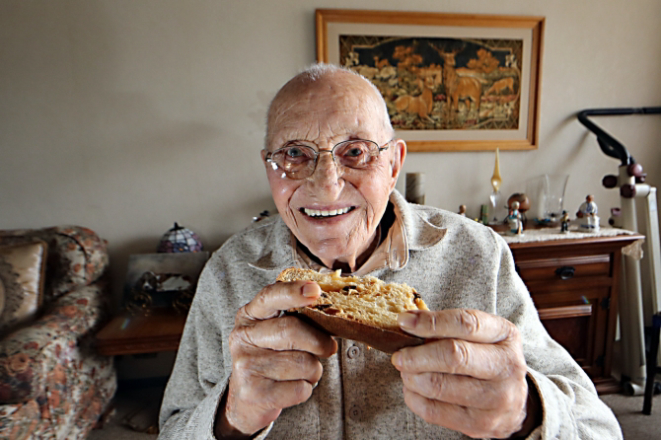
top-left (265, 139), bottom-right (393, 180)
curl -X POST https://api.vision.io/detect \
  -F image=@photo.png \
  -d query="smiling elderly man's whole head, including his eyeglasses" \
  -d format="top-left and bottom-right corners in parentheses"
top-left (262, 72), bottom-right (406, 272)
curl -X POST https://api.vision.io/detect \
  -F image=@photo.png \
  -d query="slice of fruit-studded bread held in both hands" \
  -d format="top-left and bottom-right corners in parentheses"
top-left (278, 268), bottom-right (429, 353)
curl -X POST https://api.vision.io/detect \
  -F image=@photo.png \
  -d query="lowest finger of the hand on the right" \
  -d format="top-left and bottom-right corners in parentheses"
top-left (404, 387), bottom-right (525, 438)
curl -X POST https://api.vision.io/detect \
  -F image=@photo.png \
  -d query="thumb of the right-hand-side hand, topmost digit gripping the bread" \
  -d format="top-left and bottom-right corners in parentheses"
top-left (398, 309), bottom-right (515, 343)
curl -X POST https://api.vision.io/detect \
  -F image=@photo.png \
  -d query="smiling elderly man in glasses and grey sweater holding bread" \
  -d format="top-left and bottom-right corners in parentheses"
top-left (161, 65), bottom-right (621, 439)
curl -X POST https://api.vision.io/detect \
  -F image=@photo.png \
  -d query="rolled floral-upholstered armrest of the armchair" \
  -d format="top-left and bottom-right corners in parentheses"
top-left (0, 284), bottom-right (108, 403)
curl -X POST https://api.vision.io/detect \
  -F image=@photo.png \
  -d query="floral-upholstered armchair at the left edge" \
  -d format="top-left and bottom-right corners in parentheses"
top-left (0, 226), bottom-right (117, 439)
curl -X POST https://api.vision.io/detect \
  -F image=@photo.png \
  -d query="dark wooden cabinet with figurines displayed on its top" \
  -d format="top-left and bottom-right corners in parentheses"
top-left (509, 235), bottom-right (643, 393)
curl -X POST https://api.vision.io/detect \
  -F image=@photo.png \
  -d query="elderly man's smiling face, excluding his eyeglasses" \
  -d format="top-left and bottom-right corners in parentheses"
top-left (262, 73), bottom-right (406, 270)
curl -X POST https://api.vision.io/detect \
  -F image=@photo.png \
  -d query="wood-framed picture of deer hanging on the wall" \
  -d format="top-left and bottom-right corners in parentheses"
top-left (316, 9), bottom-right (545, 152)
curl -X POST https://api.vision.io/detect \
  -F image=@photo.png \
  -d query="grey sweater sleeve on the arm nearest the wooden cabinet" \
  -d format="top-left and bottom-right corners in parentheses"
top-left (494, 234), bottom-right (622, 440)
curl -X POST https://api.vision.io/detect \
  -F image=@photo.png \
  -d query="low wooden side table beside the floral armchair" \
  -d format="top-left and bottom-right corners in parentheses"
top-left (96, 308), bottom-right (186, 356)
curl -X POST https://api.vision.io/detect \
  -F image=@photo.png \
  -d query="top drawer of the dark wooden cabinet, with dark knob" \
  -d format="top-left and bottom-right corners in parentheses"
top-left (516, 254), bottom-right (611, 281)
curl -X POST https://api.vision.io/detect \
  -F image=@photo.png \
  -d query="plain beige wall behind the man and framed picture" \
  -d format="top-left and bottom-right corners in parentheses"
top-left (0, 0), bottom-right (661, 312)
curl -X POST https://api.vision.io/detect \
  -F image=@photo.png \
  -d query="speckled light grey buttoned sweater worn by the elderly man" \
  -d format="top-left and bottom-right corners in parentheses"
top-left (159, 192), bottom-right (622, 440)
